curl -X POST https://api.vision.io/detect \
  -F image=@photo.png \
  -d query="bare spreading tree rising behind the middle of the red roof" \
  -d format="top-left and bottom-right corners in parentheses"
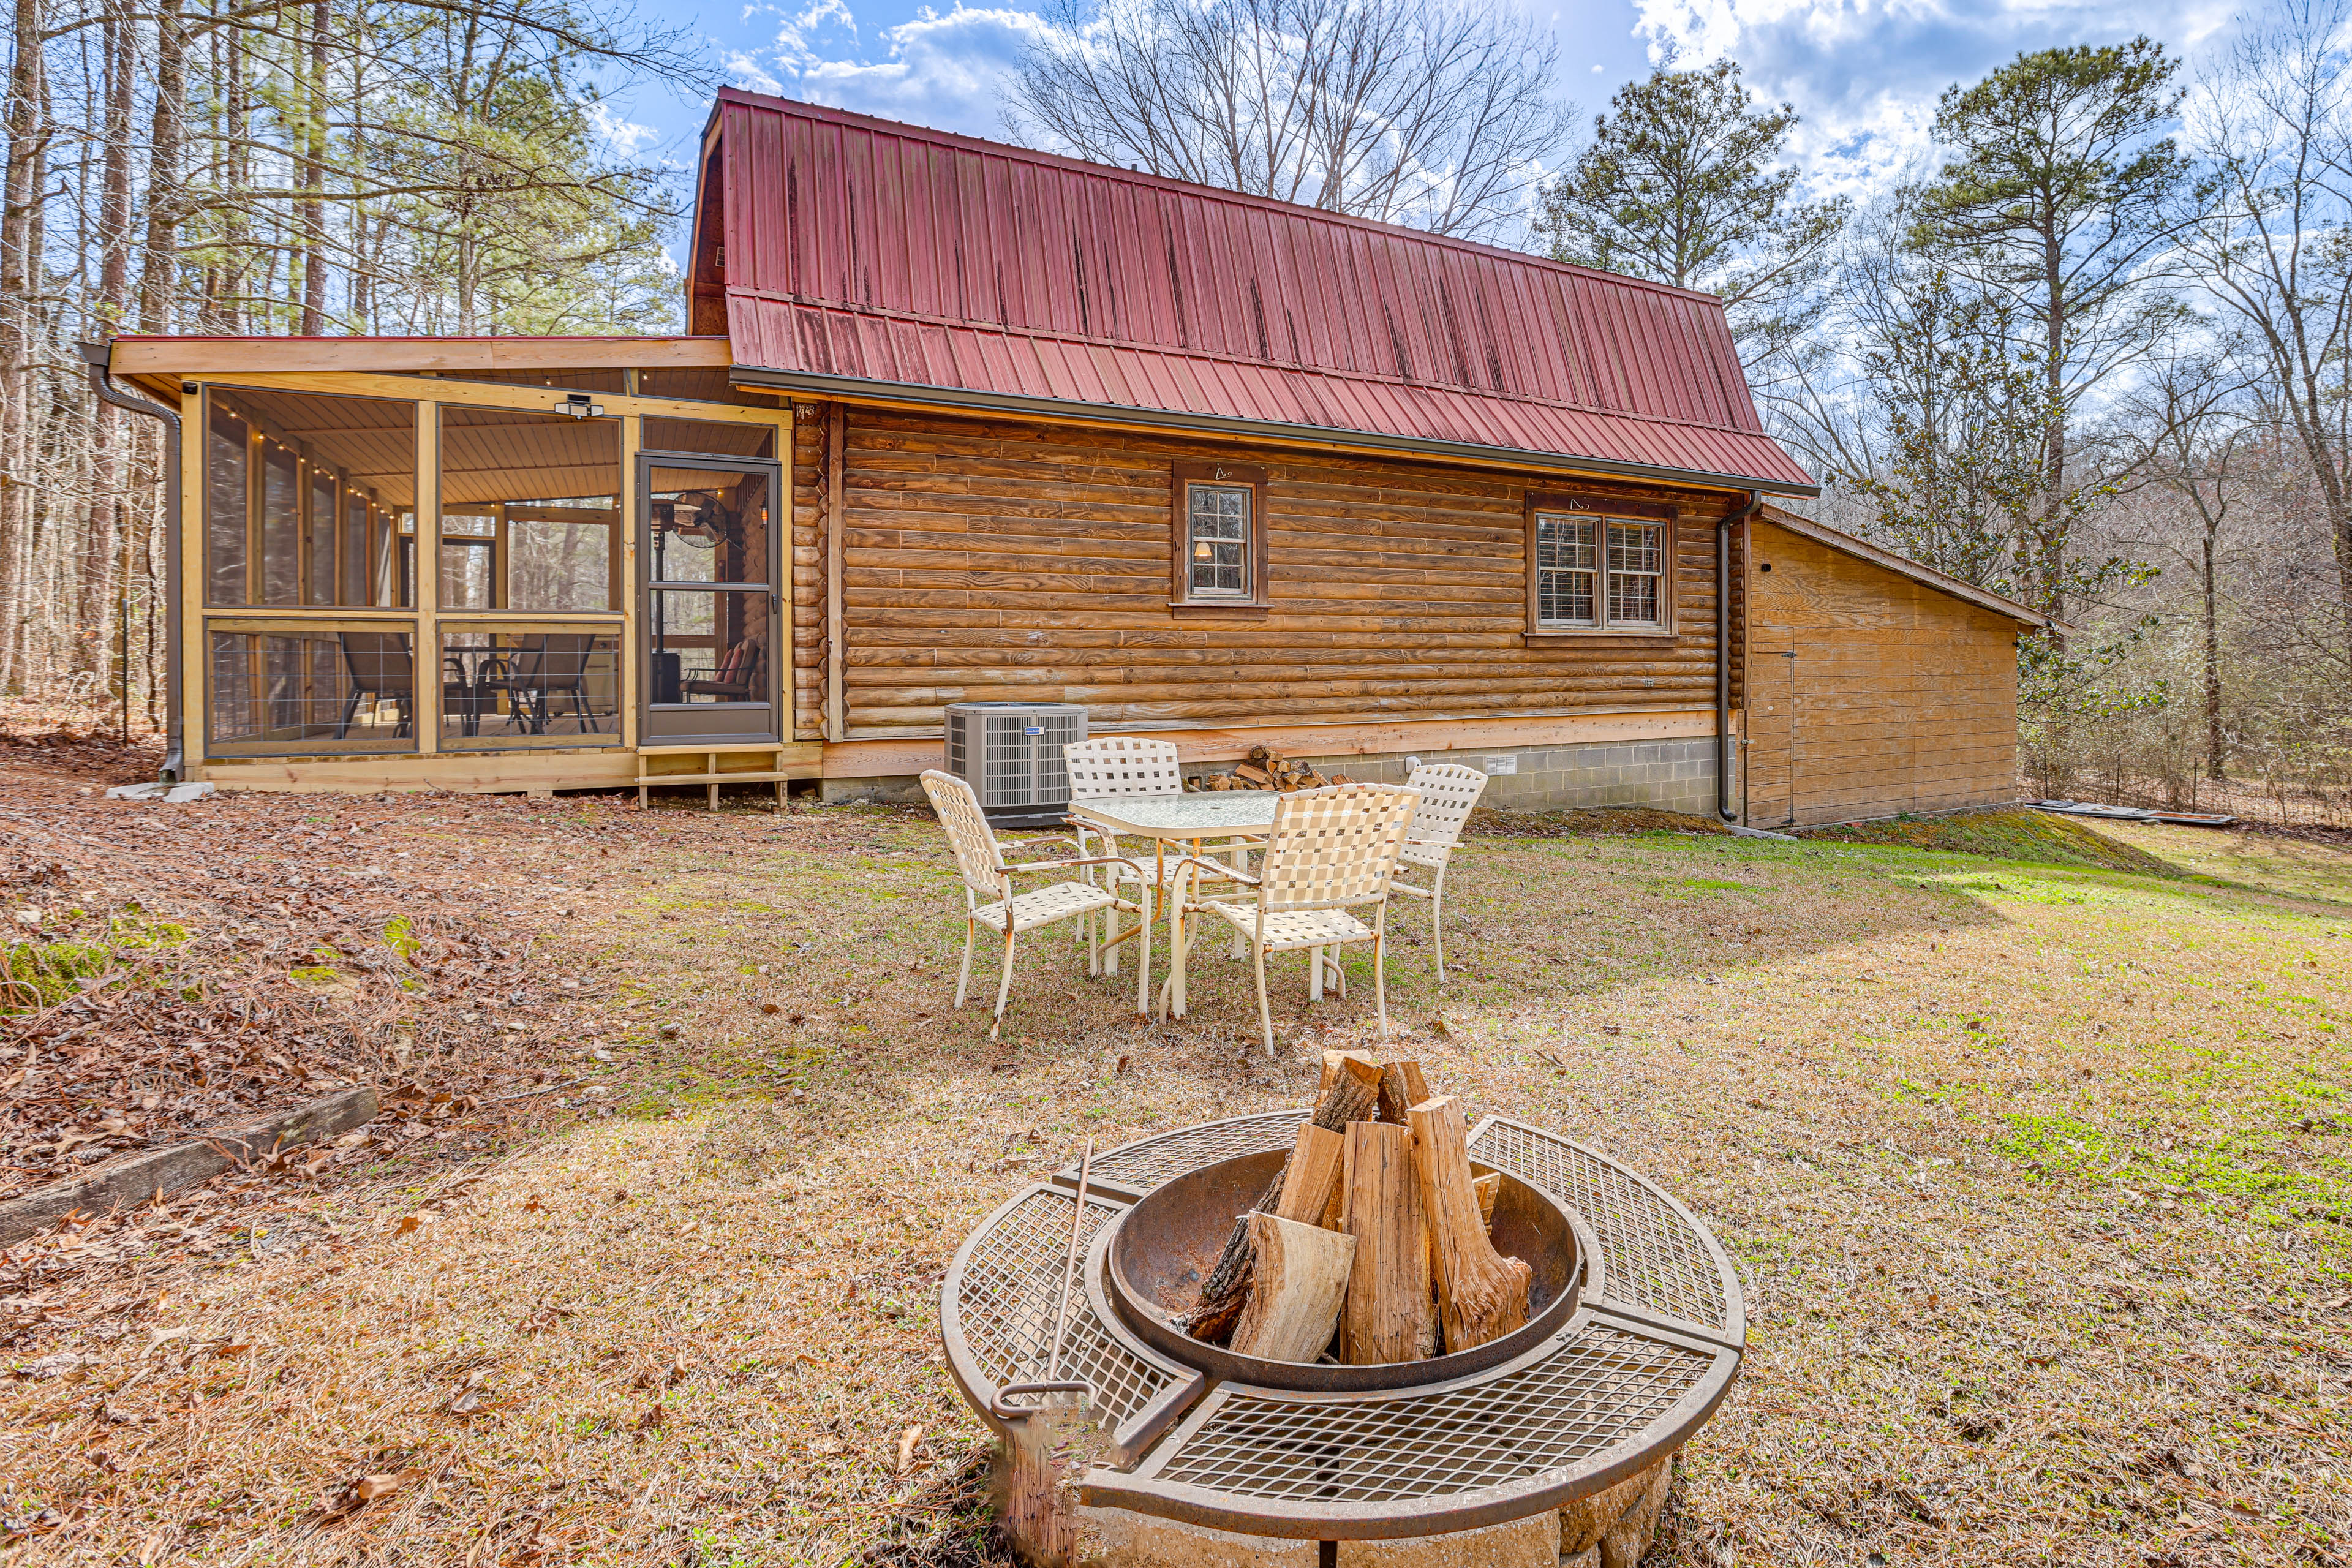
top-left (1007, 0), bottom-right (1574, 239)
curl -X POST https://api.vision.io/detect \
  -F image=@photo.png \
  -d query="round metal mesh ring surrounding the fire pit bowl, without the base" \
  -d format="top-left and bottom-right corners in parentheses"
top-left (941, 1110), bottom-right (1747, 1540)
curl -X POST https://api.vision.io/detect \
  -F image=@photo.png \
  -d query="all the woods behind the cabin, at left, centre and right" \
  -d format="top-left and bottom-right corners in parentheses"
top-left (0, 0), bottom-right (2352, 818)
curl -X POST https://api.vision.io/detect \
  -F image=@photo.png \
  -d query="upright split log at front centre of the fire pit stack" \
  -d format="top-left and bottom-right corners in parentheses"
top-left (1338, 1121), bottom-right (1437, 1366)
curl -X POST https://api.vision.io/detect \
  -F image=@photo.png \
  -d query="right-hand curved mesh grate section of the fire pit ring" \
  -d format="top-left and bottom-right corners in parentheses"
top-left (1470, 1119), bottom-right (1731, 1333)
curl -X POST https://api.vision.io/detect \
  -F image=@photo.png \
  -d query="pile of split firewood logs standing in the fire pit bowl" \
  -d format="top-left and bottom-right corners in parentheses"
top-left (1181, 1051), bottom-right (1531, 1366)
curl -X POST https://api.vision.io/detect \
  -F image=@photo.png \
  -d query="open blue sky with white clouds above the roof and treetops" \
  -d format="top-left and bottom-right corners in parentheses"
top-left (611, 0), bottom-right (2237, 250)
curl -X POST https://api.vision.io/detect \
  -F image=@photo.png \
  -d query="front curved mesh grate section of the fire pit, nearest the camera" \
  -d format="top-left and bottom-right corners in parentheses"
top-left (1157, 1321), bottom-right (1714, 1502)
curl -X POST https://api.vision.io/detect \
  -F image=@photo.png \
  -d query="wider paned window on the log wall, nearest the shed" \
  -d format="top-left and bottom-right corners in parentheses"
top-left (1526, 496), bottom-right (1675, 635)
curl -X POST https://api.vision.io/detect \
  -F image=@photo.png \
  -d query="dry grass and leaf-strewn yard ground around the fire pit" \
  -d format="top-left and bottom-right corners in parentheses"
top-left (0, 745), bottom-right (2352, 1568)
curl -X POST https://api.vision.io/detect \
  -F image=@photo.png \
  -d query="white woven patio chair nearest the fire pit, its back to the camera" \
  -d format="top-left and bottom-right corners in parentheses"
top-left (1194, 785), bottom-right (1420, 1055)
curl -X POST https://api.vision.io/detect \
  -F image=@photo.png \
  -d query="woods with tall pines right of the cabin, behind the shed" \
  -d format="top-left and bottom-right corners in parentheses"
top-left (1538, 0), bottom-right (2352, 820)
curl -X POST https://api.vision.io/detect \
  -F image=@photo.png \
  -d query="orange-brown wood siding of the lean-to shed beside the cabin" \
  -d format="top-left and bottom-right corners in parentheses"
top-left (1745, 522), bottom-right (2018, 827)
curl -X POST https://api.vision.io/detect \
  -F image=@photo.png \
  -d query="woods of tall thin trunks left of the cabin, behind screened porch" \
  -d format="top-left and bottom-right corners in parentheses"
top-left (0, 0), bottom-right (696, 722)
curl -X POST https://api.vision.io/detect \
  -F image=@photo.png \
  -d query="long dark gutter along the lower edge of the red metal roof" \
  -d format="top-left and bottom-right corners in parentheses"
top-left (727, 364), bottom-right (1820, 496)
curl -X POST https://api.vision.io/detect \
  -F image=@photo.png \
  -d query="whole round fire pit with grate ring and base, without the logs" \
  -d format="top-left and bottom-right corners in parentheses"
top-left (941, 1110), bottom-right (1745, 1568)
